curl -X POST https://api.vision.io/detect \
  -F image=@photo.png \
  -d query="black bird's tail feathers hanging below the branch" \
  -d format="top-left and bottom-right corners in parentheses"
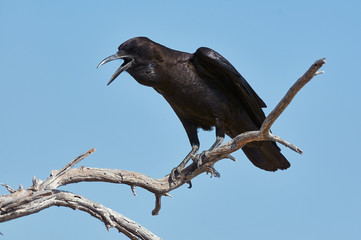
top-left (242, 141), bottom-right (291, 171)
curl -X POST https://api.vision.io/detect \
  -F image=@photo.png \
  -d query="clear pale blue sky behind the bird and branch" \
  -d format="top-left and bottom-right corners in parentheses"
top-left (0, 0), bottom-right (361, 240)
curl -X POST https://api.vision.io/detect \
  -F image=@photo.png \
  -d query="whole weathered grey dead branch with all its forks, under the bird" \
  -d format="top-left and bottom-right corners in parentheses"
top-left (0, 59), bottom-right (326, 239)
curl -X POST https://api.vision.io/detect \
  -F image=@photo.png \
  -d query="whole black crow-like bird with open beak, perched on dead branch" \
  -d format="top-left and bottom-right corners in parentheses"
top-left (98, 37), bottom-right (290, 179)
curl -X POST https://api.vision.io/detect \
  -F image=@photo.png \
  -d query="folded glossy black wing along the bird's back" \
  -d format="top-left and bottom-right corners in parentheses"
top-left (191, 47), bottom-right (266, 126)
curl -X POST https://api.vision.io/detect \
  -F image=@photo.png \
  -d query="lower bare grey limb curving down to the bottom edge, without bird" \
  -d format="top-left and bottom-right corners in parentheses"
top-left (0, 189), bottom-right (160, 239)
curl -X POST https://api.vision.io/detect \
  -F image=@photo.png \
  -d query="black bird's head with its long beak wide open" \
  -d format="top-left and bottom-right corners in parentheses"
top-left (97, 37), bottom-right (162, 85)
